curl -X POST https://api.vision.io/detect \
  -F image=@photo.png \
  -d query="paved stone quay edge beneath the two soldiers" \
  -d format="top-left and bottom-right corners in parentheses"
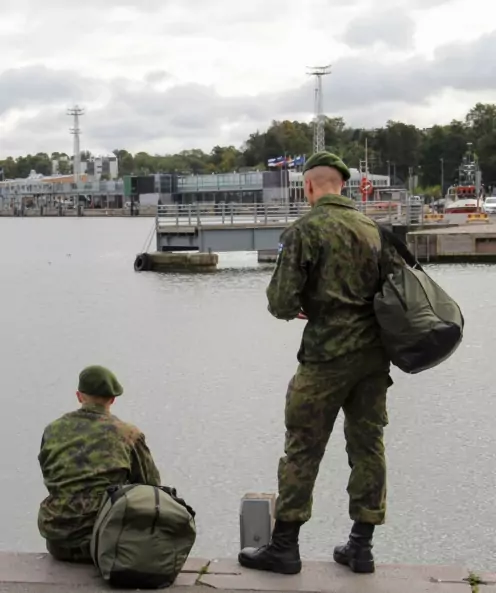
top-left (0, 553), bottom-right (490, 593)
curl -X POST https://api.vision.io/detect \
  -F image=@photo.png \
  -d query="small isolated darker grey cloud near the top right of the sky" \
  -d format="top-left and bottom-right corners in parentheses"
top-left (343, 8), bottom-right (415, 50)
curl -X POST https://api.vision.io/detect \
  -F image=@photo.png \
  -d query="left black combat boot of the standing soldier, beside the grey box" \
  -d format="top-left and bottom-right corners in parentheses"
top-left (238, 521), bottom-right (302, 574)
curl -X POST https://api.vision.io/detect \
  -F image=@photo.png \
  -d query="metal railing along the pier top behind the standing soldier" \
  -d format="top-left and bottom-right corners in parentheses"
top-left (157, 202), bottom-right (404, 226)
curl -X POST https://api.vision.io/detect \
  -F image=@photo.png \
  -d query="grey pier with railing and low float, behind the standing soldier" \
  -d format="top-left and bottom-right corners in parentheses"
top-left (134, 201), bottom-right (425, 271)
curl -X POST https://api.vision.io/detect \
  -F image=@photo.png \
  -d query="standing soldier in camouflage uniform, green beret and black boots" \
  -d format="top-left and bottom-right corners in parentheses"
top-left (239, 152), bottom-right (392, 574)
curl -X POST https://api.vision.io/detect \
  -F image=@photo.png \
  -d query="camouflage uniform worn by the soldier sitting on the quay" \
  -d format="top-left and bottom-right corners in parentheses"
top-left (38, 404), bottom-right (160, 546)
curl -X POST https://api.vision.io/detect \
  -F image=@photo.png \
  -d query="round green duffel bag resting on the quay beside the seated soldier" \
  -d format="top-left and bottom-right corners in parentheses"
top-left (91, 484), bottom-right (196, 589)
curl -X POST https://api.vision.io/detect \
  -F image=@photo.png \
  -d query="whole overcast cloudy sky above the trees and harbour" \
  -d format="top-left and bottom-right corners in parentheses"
top-left (0, 0), bottom-right (496, 158)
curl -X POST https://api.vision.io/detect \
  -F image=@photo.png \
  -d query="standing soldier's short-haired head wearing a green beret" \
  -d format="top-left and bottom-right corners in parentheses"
top-left (303, 151), bottom-right (351, 205)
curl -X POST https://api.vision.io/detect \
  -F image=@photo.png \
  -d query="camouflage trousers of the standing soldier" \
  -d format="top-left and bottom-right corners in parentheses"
top-left (276, 349), bottom-right (392, 525)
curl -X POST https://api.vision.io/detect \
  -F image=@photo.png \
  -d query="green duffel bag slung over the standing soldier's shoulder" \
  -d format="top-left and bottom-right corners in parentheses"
top-left (374, 226), bottom-right (465, 374)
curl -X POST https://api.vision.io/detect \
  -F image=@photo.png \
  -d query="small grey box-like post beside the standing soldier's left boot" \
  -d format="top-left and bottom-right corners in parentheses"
top-left (239, 493), bottom-right (277, 549)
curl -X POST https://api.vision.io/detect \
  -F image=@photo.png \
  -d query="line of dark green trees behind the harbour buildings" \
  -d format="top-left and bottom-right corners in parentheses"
top-left (0, 103), bottom-right (496, 187)
